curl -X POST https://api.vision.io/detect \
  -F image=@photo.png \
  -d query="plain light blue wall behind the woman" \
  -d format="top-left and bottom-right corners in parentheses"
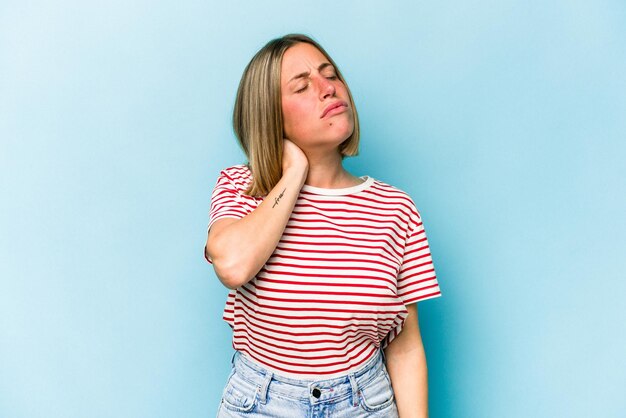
top-left (0, 0), bottom-right (626, 418)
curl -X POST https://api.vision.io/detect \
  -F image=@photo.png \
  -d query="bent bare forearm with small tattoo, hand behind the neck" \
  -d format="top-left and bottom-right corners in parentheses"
top-left (206, 139), bottom-right (308, 289)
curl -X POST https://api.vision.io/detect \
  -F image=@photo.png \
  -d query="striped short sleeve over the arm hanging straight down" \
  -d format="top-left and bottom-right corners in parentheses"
top-left (397, 210), bottom-right (441, 305)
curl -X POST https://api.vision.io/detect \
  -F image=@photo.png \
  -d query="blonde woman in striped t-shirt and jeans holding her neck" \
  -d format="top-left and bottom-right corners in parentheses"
top-left (205, 35), bottom-right (441, 418)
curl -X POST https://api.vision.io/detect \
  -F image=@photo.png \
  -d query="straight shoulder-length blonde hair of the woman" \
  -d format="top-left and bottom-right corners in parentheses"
top-left (233, 34), bottom-right (359, 196)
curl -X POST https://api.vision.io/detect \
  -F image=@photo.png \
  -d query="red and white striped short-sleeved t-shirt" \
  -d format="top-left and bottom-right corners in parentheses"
top-left (207, 164), bottom-right (441, 380)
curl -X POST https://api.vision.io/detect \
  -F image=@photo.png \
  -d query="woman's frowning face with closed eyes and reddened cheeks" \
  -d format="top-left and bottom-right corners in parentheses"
top-left (280, 43), bottom-right (354, 151)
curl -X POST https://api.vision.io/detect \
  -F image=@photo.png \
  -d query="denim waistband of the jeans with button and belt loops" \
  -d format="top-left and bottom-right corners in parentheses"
top-left (231, 348), bottom-right (387, 405)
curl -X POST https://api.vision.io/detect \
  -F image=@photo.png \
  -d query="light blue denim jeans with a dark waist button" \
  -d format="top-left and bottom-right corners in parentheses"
top-left (217, 349), bottom-right (398, 418)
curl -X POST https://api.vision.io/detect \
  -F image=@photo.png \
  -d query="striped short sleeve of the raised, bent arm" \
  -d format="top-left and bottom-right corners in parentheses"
top-left (204, 170), bottom-right (249, 264)
